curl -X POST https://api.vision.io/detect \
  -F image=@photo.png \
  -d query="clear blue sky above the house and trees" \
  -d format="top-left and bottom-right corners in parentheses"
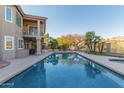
top-left (22, 5), bottom-right (124, 38)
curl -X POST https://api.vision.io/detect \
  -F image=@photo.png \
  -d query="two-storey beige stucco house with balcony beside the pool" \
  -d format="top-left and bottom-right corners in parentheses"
top-left (0, 5), bottom-right (47, 60)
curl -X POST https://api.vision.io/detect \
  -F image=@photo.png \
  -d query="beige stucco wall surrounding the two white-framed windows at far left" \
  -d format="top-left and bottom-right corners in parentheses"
top-left (0, 6), bottom-right (25, 60)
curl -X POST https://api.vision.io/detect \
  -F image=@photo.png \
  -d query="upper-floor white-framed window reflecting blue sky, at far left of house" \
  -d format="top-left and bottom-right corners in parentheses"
top-left (5, 6), bottom-right (13, 23)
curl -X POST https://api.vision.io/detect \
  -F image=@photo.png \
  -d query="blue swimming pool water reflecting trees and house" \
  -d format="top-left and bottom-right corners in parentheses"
top-left (0, 53), bottom-right (124, 88)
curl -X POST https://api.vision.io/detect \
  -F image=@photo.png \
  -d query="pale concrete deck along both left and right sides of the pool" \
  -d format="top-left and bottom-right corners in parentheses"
top-left (0, 51), bottom-right (124, 84)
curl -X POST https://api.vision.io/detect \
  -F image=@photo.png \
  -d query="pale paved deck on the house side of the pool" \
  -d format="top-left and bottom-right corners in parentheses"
top-left (0, 52), bottom-right (52, 84)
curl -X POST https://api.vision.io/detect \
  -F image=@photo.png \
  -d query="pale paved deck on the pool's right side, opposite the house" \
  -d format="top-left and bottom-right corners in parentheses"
top-left (77, 52), bottom-right (124, 75)
